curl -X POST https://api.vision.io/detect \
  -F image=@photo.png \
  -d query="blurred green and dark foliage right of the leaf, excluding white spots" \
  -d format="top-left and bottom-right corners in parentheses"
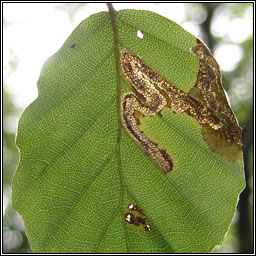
top-left (195, 3), bottom-right (253, 253)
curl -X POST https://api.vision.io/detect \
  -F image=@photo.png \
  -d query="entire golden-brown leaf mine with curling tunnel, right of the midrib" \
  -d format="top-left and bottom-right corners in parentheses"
top-left (121, 45), bottom-right (241, 163)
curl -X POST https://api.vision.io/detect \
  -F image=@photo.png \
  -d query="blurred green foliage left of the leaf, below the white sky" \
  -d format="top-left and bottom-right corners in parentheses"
top-left (3, 89), bottom-right (31, 253)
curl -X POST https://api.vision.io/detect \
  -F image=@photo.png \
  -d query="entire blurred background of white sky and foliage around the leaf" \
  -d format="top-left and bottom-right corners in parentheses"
top-left (3, 3), bottom-right (253, 253)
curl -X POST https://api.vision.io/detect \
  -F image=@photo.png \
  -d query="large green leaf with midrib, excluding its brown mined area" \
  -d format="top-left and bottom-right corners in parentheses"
top-left (12, 10), bottom-right (245, 253)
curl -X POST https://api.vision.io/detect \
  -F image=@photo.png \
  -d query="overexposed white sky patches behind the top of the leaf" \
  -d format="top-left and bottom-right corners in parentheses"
top-left (3, 3), bottom-right (252, 108)
